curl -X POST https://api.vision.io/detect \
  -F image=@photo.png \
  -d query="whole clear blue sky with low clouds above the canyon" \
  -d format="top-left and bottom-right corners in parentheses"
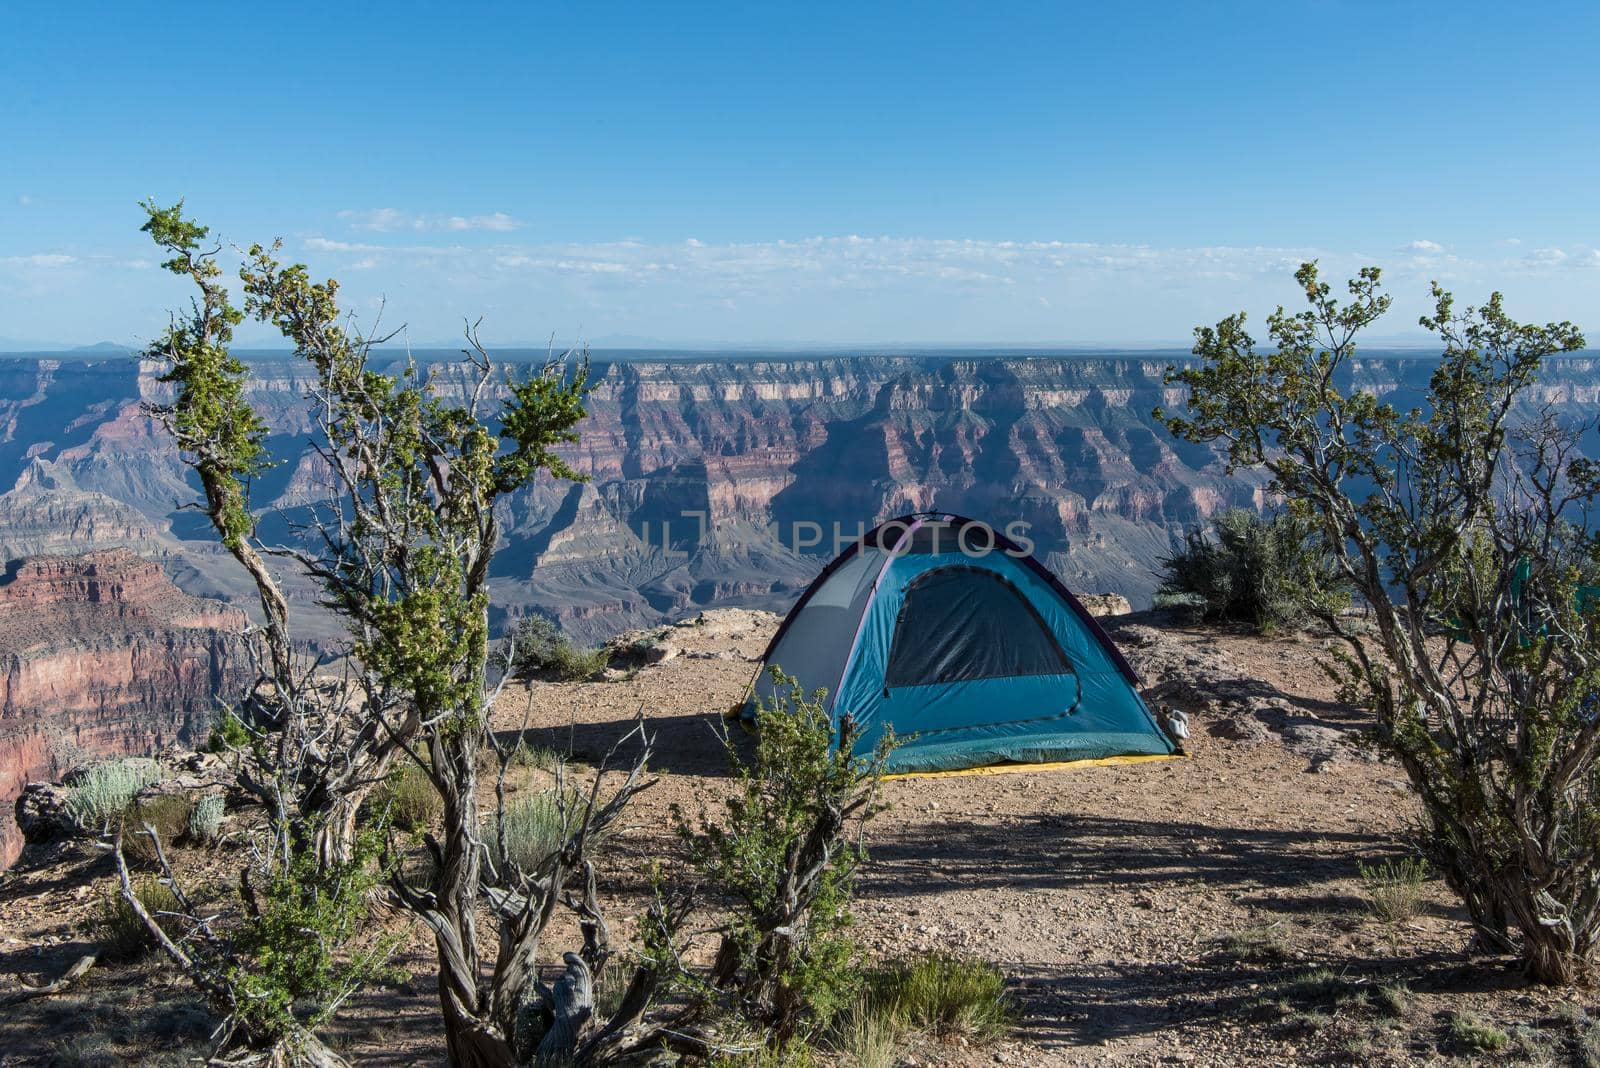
top-left (0, 0), bottom-right (1600, 344)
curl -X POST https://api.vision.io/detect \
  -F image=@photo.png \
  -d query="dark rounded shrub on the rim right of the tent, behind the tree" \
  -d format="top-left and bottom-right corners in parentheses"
top-left (1160, 508), bottom-right (1349, 633)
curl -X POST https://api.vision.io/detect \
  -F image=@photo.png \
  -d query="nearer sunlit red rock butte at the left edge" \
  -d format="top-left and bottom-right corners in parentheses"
top-left (0, 548), bottom-right (248, 865)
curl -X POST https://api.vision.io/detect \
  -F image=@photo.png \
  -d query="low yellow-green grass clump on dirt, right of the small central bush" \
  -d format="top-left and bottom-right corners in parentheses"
top-left (870, 953), bottom-right (1014, 1038)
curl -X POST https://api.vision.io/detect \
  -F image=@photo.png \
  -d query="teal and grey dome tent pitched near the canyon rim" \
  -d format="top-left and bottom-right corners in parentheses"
top-left (742, 513), bottom-right (1174, 772)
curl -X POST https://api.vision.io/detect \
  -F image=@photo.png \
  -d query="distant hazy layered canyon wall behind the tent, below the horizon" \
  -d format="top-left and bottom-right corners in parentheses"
top-left (0, 353), bottom-right (1600, 643)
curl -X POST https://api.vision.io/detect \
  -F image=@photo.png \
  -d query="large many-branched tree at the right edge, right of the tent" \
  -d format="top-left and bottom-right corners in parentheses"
top-left (1157, 264), bottom-right (1600, 983)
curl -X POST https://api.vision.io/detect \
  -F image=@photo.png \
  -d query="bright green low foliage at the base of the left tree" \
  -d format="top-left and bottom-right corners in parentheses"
top-left (226, 835), bottom-right (398, 1036)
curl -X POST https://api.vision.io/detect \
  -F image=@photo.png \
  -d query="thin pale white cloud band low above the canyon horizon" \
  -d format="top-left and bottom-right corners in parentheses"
top-left (15, 230), bottom-right (1600, 342)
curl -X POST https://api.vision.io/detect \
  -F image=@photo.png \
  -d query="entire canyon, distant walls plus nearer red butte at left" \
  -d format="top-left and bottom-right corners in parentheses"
top-left (0, 353), bottom-right (1600, 869)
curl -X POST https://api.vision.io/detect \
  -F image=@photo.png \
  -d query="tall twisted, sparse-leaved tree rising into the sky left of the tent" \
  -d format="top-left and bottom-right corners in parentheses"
top-left (118, 203), bottom-right (601, 1065)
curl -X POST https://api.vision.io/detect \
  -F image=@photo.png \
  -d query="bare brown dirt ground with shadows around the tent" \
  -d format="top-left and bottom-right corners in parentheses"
top-left (0, 611), bottom-right (1600, 1066)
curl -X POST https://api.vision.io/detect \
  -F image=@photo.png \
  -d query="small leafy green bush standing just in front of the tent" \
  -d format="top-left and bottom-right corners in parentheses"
top-left (674, 667), bottom-right (894, 1039)
